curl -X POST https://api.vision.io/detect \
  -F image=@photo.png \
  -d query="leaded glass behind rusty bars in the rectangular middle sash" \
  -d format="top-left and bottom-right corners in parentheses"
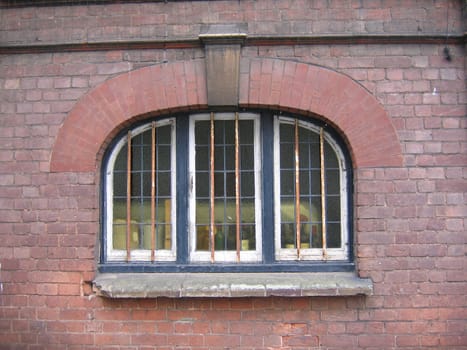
top-left (195, 119), bottom-right (256, 251)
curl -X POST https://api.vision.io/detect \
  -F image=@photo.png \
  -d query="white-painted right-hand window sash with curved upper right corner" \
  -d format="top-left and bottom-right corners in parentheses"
top-left (274, 116), bottom-right (348, 261)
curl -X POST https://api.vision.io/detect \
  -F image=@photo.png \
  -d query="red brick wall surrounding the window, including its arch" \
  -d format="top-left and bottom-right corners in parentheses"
top-left (0, 0), bottom-right (467, 350)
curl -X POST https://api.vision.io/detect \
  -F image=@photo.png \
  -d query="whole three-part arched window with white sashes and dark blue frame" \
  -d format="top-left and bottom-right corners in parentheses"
top-left (101, 111), bottom-right (353, 272)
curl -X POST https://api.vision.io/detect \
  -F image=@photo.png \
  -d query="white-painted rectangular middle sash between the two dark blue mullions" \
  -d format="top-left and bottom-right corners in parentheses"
top-left (188, 113), bottom-right (262, 263)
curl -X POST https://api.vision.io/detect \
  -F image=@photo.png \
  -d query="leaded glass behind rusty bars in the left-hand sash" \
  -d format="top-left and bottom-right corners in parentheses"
top-left (112, 125), bottom-right (172, 250)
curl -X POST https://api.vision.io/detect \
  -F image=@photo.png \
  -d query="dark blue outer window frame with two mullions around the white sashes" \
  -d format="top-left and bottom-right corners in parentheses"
top-left (98, 109), bottom-right (355, 273)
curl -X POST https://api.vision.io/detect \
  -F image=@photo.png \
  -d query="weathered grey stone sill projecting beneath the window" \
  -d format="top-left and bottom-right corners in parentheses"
top-left (93, 272), bottom-right (373, 298)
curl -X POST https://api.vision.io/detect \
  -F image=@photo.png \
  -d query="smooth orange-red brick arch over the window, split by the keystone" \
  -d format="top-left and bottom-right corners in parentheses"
top-left (50, 59), bottom-right (402, 172)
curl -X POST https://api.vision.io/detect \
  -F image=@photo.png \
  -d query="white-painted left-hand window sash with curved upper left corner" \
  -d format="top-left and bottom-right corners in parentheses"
top-left (105, 118), bottom-right (177, 262)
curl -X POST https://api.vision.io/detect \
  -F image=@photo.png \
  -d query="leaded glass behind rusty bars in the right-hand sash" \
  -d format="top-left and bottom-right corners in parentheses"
top-left (279, 122), bottom-right (341, 249)
